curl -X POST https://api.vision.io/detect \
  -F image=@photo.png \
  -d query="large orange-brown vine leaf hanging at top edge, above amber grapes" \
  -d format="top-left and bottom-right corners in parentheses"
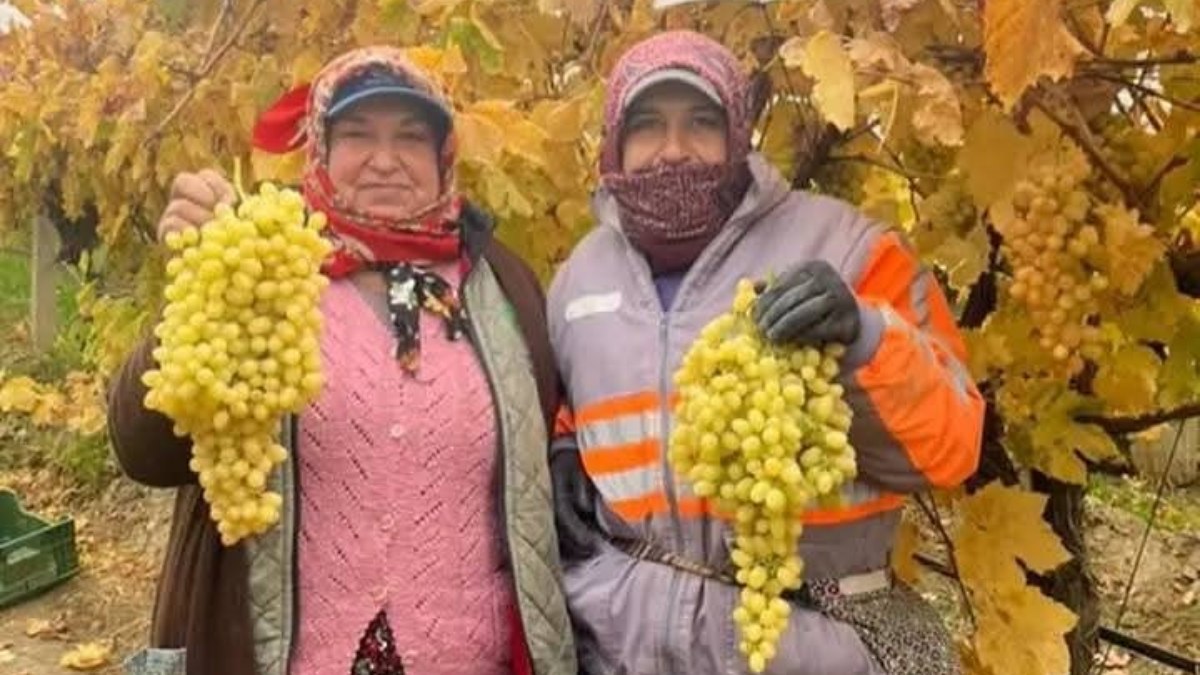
top-left (984, 0), bottom-right (1084, 112)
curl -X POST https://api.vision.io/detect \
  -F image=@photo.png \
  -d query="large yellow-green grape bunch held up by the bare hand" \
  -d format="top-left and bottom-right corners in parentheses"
top-left (143, 184), bottom-right (330, 545)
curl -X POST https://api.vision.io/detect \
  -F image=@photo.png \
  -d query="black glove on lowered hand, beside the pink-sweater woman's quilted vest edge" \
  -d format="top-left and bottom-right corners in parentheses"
top-left (550, 443), bottom-right (601, 561)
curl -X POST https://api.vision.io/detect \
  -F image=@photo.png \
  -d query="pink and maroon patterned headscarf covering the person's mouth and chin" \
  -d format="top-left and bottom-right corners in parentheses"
top-left (600, 31), bottom-right (752, 273)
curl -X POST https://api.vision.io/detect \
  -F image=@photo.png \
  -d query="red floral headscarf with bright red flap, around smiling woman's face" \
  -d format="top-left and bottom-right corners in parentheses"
top-left (254, 47), bottom-right (463, 277)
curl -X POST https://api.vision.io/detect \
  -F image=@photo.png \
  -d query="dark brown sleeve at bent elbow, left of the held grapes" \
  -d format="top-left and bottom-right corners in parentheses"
top-left (108, 335), bottom-right (196, 488)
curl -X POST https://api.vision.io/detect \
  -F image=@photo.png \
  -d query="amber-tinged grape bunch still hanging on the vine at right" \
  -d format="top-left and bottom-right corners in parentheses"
top-left (996, 147), bottom-right (1109, 374)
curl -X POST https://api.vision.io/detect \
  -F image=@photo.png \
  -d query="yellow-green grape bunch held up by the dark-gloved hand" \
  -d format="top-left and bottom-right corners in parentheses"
top-left (670, 280), bottom-right (858, 673)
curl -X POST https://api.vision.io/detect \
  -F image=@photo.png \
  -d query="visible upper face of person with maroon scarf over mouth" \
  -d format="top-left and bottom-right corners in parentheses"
top-left (620, 82), bottom-right (728, 173)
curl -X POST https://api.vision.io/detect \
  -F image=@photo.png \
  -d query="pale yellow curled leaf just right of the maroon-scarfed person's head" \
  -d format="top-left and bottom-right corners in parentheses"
top-left (780, 30), bottom-right (854, 131)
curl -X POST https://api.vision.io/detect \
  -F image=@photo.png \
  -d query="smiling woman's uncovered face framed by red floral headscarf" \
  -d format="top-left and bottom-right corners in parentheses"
top-left (329, 98), bottom-right (442, 219)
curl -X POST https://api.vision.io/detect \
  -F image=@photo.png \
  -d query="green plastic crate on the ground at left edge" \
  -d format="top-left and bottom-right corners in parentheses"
top-left (0, 490), bottom-right (79, 609)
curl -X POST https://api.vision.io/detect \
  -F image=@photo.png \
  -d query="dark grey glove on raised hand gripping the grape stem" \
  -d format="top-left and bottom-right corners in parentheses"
top-left (754, 261), bottom-right (859, 346)
